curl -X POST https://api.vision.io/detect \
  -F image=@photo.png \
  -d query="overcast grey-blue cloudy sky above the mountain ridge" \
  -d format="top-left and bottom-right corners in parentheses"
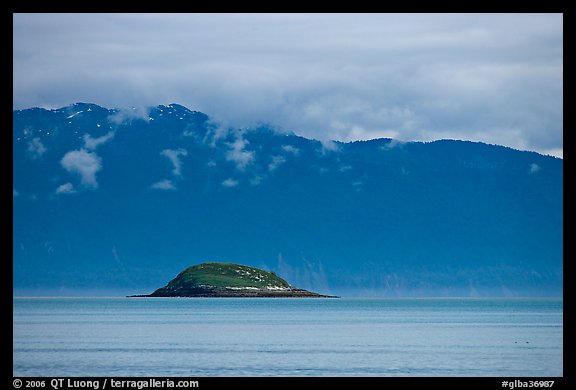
top-left (13, 14), bottom-right (563, 157)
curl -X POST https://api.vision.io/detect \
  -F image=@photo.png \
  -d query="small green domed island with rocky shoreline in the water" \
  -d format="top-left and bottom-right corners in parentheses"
top-left (131, 262), bottom-right (337, 298)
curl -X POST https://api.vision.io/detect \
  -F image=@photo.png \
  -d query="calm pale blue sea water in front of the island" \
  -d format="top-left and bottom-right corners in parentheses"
top-left (13, 298), bottom-right (563, 377)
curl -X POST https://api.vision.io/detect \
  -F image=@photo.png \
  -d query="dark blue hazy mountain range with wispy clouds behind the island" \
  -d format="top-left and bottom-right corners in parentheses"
top-left (13, 103), bottom-right (563, 296)
